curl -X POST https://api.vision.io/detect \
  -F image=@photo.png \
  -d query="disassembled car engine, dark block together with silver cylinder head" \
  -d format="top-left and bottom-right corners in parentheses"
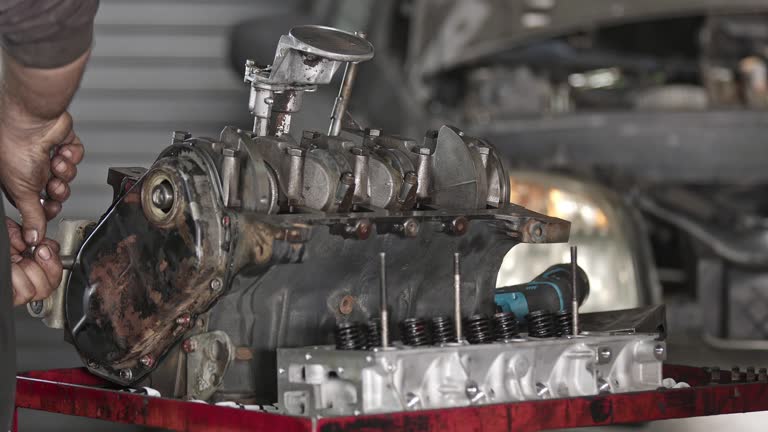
top-left (30, 26), bottom-right (665, 415)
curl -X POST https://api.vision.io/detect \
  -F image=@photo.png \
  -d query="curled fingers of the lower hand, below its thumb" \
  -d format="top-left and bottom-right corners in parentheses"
top-left (11, 245), bottom-right (62, 305)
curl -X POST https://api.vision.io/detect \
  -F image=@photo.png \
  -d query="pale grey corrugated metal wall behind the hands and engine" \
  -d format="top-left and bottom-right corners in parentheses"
top-left (15, 0), bottom-right (295, 430)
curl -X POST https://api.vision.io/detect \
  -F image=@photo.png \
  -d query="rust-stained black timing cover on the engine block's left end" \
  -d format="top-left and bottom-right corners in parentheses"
top-left (66, 147), bottom-right (227, 384)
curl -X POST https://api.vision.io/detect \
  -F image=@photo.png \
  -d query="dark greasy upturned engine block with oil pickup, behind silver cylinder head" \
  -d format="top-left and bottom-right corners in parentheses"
top-left (57, 26), bottom-right (570, 403)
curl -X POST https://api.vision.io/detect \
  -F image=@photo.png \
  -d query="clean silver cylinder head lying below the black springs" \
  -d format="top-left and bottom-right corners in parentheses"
top-left (277, 333), bottom-right (664, 417)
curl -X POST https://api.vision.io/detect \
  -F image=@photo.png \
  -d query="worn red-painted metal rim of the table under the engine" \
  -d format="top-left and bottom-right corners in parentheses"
top-left (16, 366), bottom-right (768, 432)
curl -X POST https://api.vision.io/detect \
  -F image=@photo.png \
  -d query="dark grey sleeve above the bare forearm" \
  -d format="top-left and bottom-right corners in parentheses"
top-left (0, 0), bottom-right (99, 68)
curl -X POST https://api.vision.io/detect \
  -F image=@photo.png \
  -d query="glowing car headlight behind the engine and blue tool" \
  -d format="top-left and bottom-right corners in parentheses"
top-left (496, 171), bottom-right (658, 312)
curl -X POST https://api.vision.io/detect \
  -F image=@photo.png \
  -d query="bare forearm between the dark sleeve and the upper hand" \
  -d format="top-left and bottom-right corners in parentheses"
top-left (0, 50), bottom-right (90, 127)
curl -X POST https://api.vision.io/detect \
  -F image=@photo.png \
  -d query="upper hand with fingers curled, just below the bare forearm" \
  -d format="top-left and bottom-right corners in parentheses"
top-left (0, 111), bottom-right (84, 246)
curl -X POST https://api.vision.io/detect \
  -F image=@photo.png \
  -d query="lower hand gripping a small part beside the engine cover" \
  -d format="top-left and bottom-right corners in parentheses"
top-left (5, 218), bottom-right (62, 306)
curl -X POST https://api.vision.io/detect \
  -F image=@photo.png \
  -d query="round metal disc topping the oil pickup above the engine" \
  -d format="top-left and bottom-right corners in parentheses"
top-left (289, 25), bottom-right (373, 62)
